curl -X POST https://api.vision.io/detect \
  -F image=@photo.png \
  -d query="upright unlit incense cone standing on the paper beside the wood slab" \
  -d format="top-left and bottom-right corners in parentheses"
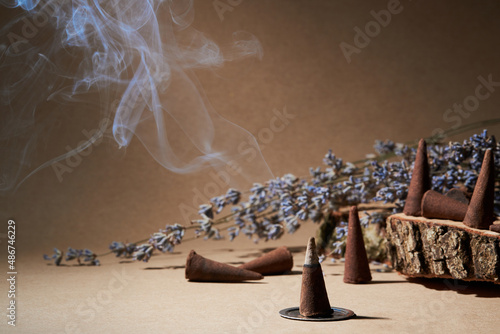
top-left (344, 206), bottom-right (372, 284)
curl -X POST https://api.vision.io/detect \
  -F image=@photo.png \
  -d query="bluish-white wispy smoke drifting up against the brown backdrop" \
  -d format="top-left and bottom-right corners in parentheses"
top-left (0, 0), bottom-right (271, 193)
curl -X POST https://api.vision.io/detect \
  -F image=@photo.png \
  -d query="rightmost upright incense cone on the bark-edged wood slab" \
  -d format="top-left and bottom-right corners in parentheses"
top-left (464, 149), bottom-right (495, 229)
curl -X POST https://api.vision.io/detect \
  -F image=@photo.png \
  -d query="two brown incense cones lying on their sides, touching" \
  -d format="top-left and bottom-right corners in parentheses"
top-left (186, 246), bottom-right (293, 282)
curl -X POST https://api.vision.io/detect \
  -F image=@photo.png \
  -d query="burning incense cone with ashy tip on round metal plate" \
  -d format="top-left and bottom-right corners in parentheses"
top-left (299, 238), bottom-right (333, 317)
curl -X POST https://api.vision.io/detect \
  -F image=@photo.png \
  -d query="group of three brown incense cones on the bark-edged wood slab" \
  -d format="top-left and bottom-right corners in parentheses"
top-left (403, 139), bottom-right (500, 231)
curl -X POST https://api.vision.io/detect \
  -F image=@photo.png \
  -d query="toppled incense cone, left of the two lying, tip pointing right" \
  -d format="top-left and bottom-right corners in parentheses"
top-left (186, 250), bottom-right (264, 282)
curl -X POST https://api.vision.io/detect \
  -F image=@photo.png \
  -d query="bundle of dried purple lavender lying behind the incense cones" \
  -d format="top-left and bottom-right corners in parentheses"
top-left (46, 120), bottom-right (500, 264)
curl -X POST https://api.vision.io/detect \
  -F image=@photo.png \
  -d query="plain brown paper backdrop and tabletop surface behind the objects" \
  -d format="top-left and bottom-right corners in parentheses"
top-left (0, 0), bottom-right (500, 333)
